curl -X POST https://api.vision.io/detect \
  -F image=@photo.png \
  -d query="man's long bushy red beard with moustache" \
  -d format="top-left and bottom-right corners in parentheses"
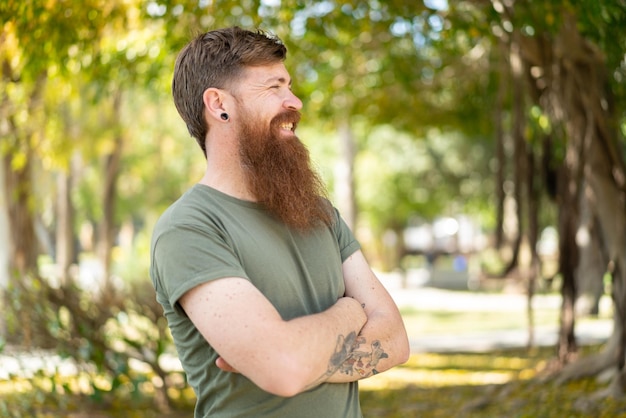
top-left (239, 111), bottom-right (332, 230)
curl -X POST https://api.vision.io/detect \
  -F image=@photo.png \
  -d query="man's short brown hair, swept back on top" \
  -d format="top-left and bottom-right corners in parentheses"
top-left (172, 26), bottom-right (287, 156)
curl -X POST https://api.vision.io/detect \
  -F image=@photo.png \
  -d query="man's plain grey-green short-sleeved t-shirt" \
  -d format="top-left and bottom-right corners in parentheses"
top-left (150, 185), bottom-right (362, 418)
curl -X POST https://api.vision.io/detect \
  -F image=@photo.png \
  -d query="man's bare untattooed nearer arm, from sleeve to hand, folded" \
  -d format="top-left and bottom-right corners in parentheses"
top-left (181, 278), bottom-right (367, 397)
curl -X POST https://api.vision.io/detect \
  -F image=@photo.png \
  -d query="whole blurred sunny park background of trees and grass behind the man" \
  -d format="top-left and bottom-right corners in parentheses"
top-left (0, 0), bottom-right (626, 417)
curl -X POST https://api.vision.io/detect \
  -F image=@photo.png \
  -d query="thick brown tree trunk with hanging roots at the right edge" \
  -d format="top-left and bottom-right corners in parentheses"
top-left (456, 0), bottom-right (626, 396)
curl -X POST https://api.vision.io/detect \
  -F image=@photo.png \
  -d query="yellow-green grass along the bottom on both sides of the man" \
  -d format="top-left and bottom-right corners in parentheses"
top-left (0, 346), bottom-right (626, 418)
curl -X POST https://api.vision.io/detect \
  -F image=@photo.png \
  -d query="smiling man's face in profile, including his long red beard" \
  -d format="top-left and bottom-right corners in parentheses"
top-left (237, 63), bottom-right (330, 230)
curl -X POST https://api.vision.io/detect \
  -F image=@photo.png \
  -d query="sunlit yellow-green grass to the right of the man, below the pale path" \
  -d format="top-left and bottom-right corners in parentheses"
top-left (361, 347), bottom-right (626, 418)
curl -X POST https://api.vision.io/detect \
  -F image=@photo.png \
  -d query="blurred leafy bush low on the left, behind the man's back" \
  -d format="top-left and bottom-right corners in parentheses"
top-left (0, 278), bottom-right (189, 416)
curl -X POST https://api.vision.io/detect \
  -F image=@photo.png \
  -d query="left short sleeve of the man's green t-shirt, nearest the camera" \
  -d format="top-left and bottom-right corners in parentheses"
top-left (152, 225), bottom-right (248, 313)
